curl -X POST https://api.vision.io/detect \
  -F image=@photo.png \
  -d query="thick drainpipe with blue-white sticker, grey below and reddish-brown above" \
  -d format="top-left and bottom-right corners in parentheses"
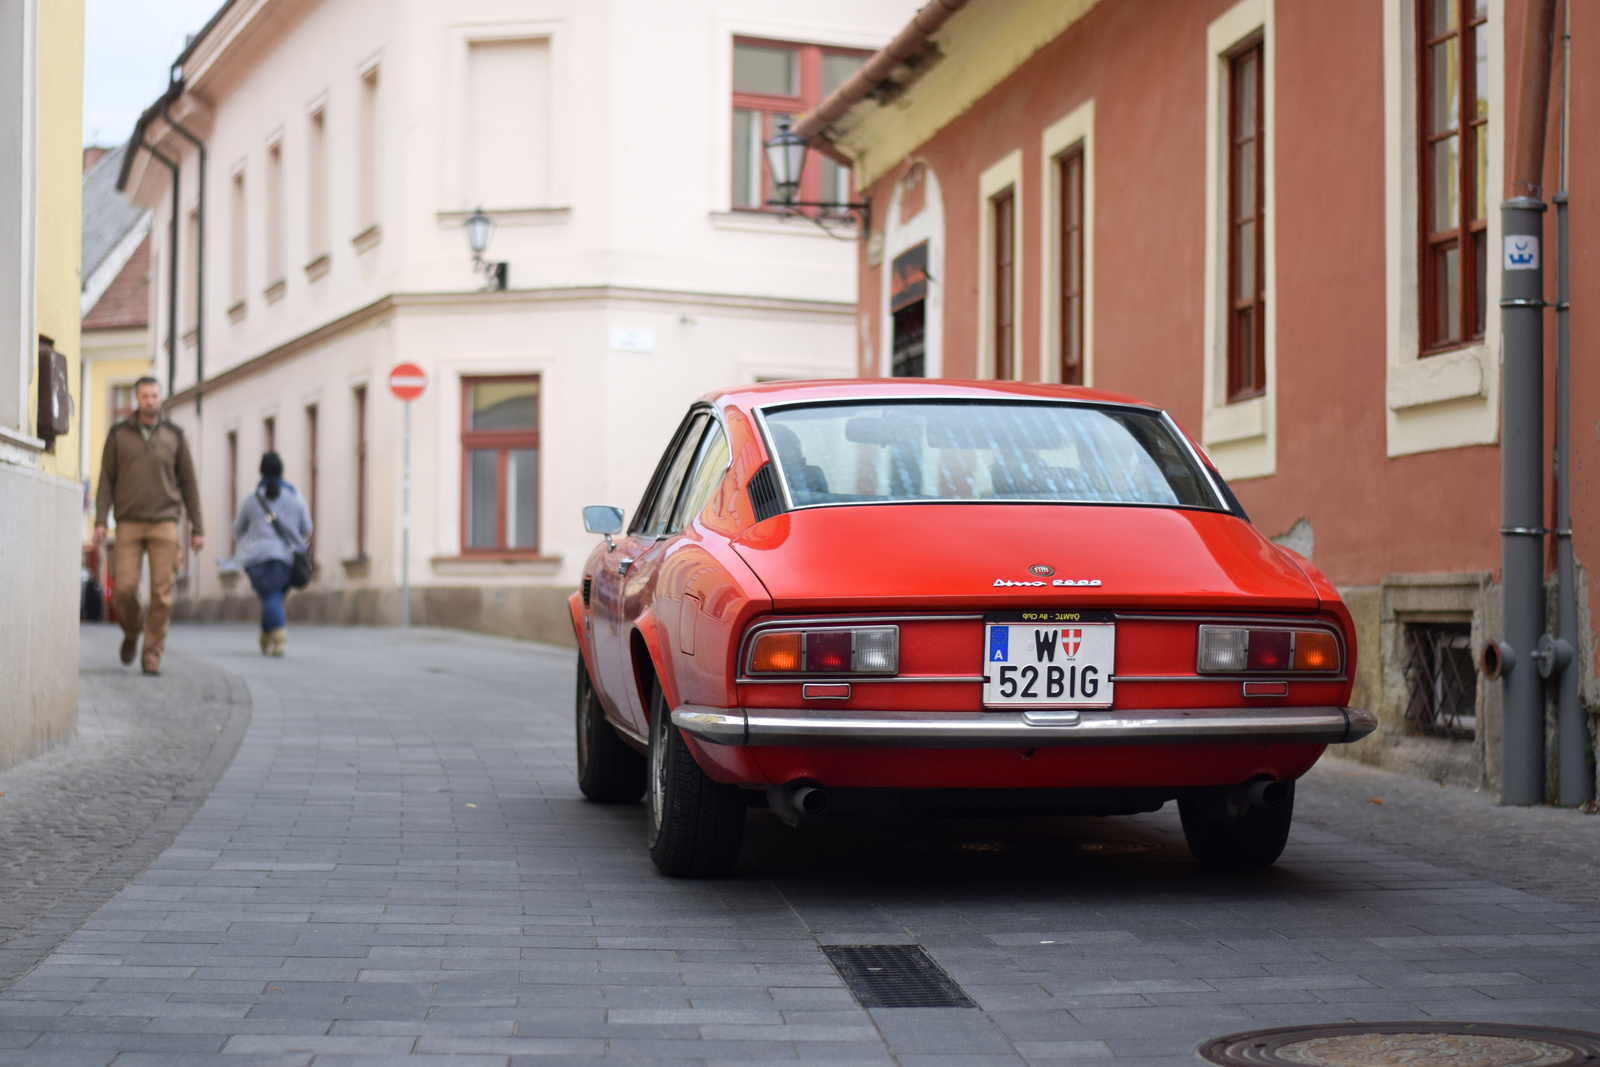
top-left (1501, 0), bottom-right (1555, 805)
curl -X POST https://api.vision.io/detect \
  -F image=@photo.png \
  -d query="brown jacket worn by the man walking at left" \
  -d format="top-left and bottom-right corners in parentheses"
top-left (94, 414), bottom-right (205, 534)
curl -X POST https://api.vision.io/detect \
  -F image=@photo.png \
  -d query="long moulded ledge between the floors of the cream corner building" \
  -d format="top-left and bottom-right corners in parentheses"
top-left (168, 285), bottom-right (856, 405)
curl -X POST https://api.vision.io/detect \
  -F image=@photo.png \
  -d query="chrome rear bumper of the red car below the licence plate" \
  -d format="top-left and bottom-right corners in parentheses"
top-left (672, 704), bottom-right (1378, 749)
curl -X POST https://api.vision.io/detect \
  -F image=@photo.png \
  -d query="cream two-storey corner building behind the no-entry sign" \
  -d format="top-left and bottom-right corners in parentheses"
top-left (122, 0), bottom-right (914, 641)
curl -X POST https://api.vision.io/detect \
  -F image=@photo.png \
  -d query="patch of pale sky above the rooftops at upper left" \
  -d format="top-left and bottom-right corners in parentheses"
top-left (83, 0), bottom-right (222, 146)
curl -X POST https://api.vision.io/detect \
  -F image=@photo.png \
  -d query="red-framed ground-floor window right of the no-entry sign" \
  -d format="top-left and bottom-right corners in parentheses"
top-left (461, 378), bottom-right (539, 555)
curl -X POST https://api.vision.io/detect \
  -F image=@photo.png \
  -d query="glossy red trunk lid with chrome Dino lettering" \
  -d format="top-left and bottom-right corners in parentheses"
top-left (734, 502), bottom-right (1318, 613)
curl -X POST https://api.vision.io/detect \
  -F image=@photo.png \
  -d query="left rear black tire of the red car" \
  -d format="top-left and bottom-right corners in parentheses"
top-left (645, 685), bottom-right (746, 878)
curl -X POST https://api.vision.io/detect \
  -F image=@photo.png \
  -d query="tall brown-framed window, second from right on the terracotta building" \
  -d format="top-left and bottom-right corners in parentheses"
top-left (1227, 38), bottom-right (1267, 403)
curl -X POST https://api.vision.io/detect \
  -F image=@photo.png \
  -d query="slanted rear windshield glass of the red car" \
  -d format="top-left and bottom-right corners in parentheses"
top-left (762, 400), bottom-right (1224, 510)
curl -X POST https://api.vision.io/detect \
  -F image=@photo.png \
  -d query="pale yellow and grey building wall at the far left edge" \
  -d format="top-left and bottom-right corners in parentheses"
top-left (0, 0), bottom-right (83, 766)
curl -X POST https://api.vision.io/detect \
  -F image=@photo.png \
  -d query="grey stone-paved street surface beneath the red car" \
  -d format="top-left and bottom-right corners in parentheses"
top-left (0, 625), bottom-right (1600, 1067)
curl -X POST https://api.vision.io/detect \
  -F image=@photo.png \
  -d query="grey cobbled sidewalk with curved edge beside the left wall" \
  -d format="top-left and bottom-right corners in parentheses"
top-left (0, 625), bottom-right (250, 989)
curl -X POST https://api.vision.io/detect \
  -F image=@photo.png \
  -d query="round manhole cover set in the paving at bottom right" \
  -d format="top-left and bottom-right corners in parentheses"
top-left (1195, 1022), bottom-right (1600, 1067)
